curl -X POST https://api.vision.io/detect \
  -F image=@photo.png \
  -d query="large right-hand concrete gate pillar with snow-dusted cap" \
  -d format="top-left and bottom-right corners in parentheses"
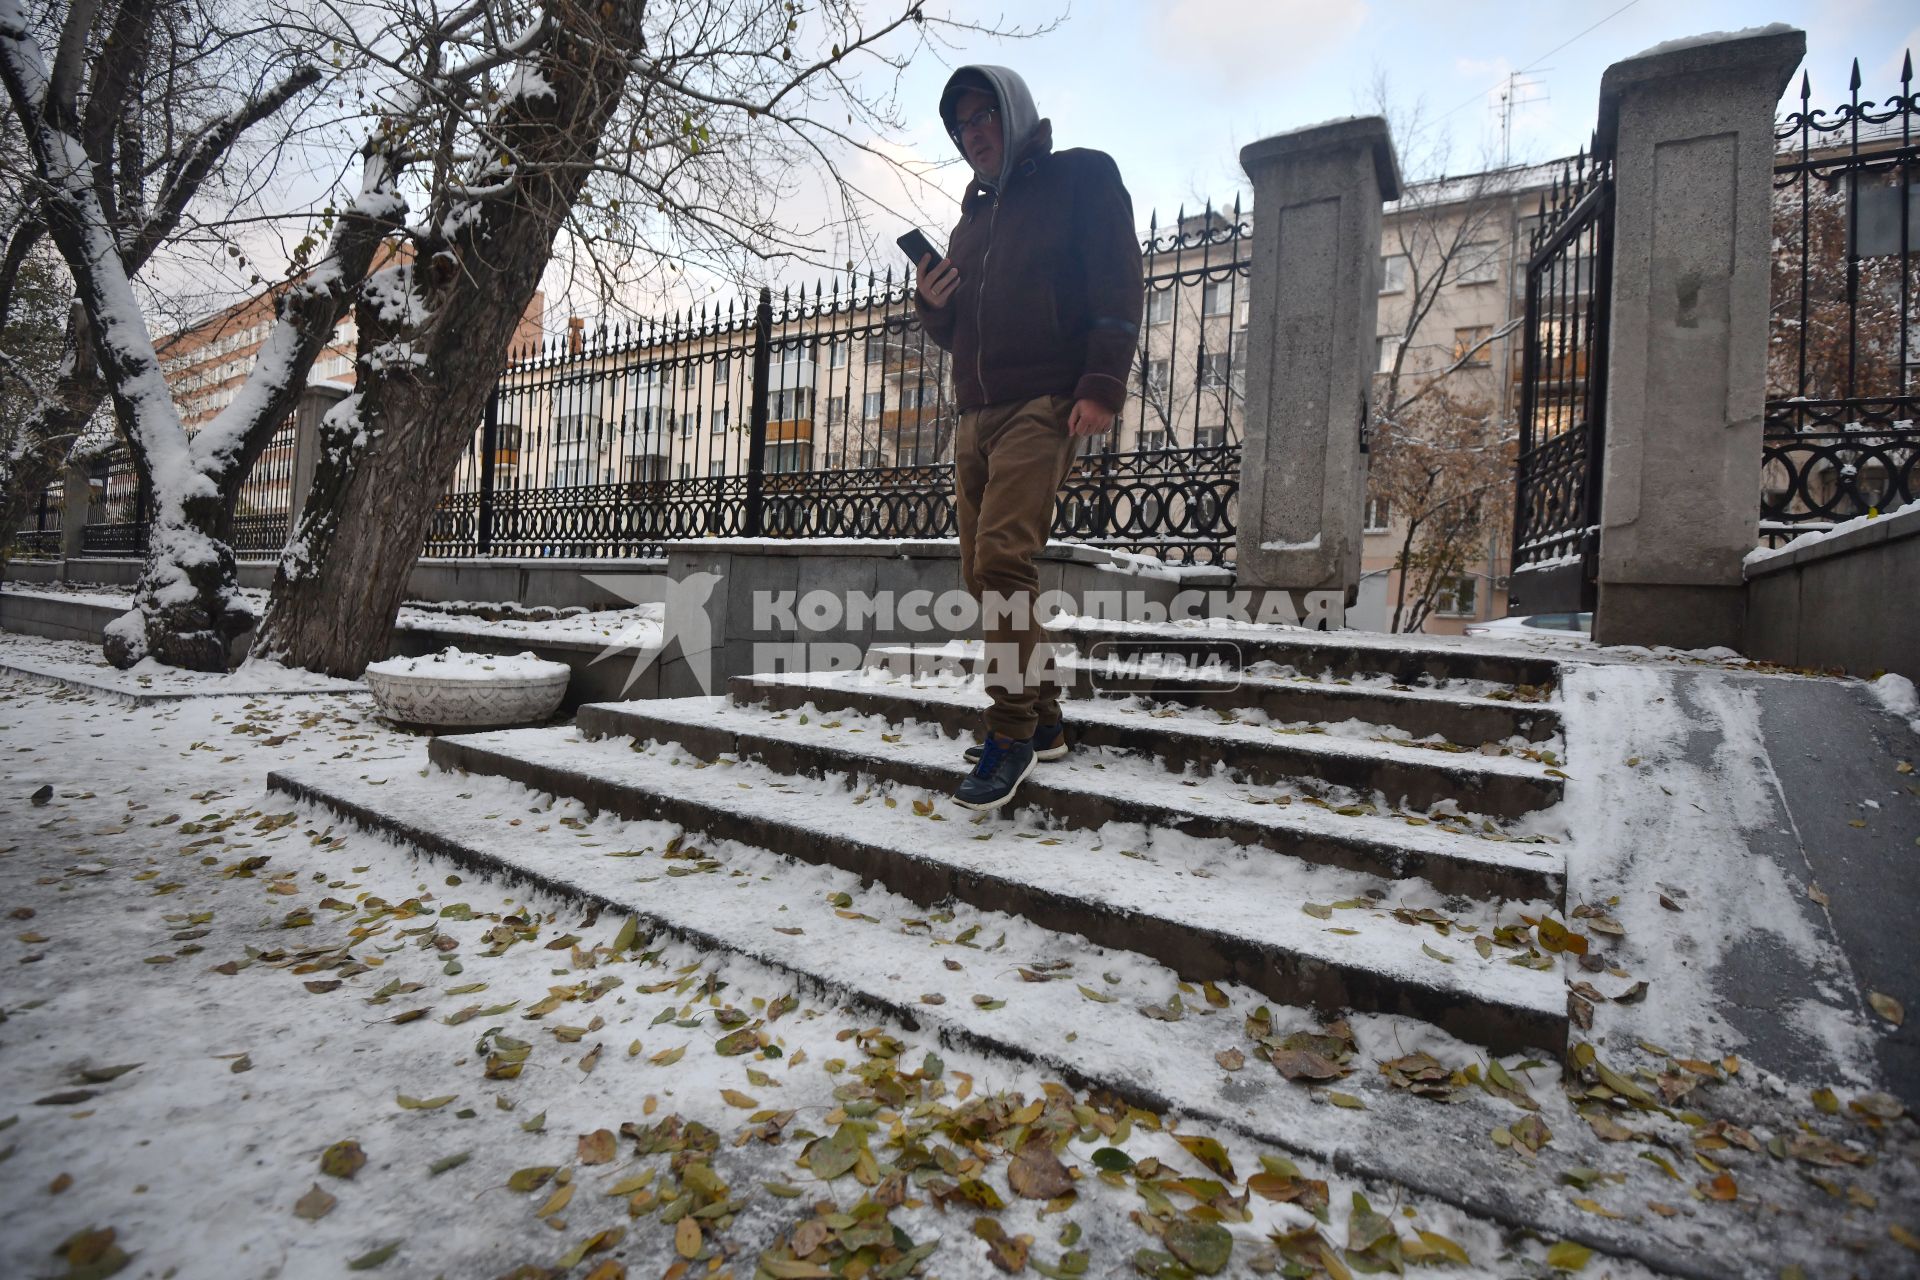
top-left (1594, 29), bottom-right (1807, 649)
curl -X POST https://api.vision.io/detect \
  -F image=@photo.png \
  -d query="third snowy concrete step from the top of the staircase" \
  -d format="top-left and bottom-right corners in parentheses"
top-left (714, 670), bottom-right (1561, 819)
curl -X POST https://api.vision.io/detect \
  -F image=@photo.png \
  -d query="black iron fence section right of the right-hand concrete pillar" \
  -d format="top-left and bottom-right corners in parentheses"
top-left (1761, 54), bottom-right (1920, 545)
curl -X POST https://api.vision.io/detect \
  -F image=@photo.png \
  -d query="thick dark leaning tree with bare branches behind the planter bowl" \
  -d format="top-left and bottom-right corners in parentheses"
top-left (255, 0), bottom-right (1029, 676)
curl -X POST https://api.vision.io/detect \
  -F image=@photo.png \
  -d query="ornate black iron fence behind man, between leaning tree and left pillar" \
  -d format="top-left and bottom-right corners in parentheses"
top-left (424, 205), bottom-right (1248, 562)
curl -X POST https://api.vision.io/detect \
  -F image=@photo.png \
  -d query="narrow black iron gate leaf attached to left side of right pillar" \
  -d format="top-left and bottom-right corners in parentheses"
top-left (1509, 152), bottom-right (1613, 612)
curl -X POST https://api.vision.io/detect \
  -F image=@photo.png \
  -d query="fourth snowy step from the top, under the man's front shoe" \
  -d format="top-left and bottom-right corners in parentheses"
top-left (578, 699), bottom-right (1565, 912)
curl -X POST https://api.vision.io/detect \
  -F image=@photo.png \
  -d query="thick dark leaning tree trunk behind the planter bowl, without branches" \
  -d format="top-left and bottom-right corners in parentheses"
top-left (253, 4), bottom-right (641, 677)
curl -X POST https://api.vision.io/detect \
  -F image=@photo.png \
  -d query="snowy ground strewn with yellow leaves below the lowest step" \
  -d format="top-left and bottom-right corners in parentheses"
top-left (0, 652), bottom-right (1645, 1280)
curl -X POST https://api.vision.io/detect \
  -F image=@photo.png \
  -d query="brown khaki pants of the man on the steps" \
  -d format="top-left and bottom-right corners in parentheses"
top-left (954, 395), bottom-right (1075, 739)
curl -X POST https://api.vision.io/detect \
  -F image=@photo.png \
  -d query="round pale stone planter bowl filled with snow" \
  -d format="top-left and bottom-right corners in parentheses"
top-left (367, 649), bottom-right (572, 729)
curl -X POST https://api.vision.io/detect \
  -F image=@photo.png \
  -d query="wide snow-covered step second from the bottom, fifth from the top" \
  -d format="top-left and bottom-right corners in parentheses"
top-left (412, 729), bottom-right (1567, 1054)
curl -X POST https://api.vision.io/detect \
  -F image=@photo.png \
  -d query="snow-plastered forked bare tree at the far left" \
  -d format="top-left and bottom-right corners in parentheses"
top-left (0, 0), bottom-right (380, 670)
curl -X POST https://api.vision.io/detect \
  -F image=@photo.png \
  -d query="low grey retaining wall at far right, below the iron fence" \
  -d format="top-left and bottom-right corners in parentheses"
top-left (1747, 507), bottom-right (1920, 679)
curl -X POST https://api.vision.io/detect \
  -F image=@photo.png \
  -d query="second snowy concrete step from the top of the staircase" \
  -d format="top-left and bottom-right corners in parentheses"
top-left (868, 643), bottom-right (1561, 747)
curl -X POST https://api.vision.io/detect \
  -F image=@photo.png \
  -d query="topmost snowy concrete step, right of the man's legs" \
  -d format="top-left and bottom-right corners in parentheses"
top-left (1048, 618), bottom-right (1559, 697)
